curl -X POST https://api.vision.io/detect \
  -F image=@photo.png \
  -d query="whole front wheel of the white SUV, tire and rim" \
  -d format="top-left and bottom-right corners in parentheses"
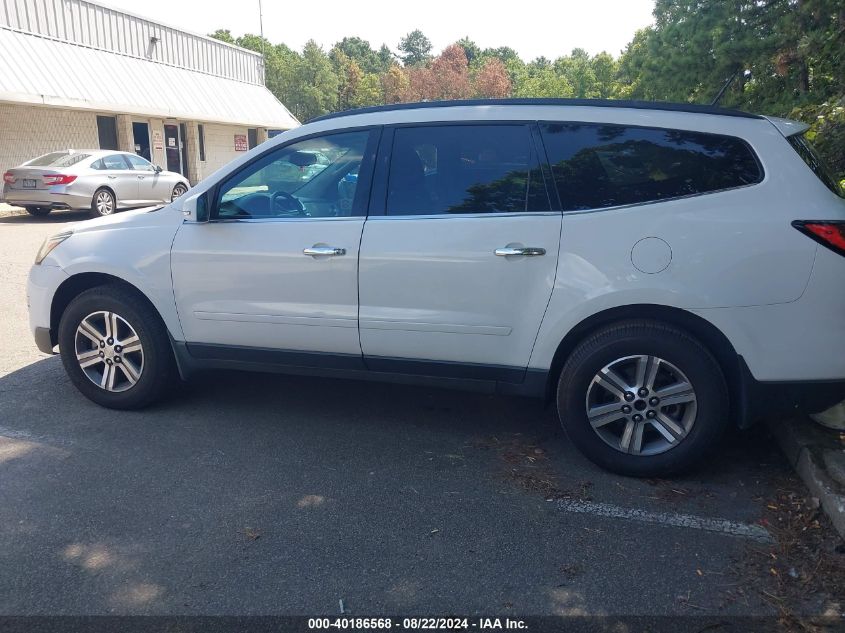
top-left (59, 284), bottom-right (177, 409)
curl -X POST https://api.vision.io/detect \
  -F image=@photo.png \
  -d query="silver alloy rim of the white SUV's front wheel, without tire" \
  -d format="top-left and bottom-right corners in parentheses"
top-left (74, 310), bottom-right (144, 392)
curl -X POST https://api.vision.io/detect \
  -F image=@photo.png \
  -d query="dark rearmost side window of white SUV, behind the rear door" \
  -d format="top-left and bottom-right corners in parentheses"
top-left (541, 123), bottom-right (763, 211)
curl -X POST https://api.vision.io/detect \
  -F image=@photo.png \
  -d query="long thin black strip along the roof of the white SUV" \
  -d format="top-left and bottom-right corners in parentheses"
top-left (308, 99), bottom-right (763, 123)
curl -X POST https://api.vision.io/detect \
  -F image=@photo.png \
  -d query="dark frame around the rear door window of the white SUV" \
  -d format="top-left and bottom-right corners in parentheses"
top-left (367, 119), bottom-right (560, 220)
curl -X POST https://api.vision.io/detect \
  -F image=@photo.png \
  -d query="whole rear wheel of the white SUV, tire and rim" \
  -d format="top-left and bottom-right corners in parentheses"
top-left (557, 320), bottom-right (729, 477)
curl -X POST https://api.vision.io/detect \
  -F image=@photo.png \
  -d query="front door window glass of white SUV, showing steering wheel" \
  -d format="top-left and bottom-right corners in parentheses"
top-left (216, 130), bottom-right (370, 219)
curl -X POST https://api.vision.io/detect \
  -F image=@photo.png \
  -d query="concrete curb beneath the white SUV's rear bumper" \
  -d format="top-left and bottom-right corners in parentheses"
top-left (768, 416), bottom-right (845, 538)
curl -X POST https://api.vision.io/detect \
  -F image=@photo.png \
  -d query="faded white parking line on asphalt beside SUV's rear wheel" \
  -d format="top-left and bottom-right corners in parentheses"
top-left (557, 499), bottom-right (773, 543)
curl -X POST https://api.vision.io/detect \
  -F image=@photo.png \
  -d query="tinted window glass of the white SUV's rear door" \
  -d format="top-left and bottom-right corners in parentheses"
top-left (387, 125), bottom-right (550, 215)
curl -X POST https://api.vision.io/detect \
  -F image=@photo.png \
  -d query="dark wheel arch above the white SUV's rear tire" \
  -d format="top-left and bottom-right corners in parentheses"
top-left (545, 304), bottom-right (747, 427)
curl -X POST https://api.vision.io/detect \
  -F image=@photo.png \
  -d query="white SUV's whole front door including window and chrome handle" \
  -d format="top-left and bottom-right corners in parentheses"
top-left (172, 130), bottom-right (377, 368)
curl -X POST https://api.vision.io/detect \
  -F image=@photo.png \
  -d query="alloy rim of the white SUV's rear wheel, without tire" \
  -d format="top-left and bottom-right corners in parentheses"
top-left (586, 355), bottom-right (697, 455)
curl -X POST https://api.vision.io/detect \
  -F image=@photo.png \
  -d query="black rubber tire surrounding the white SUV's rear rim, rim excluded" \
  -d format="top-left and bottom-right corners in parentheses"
top-left (557, 320), bottom-right (729, 477)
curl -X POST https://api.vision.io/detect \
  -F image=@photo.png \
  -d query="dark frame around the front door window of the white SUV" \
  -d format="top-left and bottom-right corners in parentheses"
top-left (205, 125), bottom-right (383, 224)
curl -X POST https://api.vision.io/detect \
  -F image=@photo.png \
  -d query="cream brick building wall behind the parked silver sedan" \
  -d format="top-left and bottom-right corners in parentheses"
top-left (0, 103), bottom-right (100, 173)
